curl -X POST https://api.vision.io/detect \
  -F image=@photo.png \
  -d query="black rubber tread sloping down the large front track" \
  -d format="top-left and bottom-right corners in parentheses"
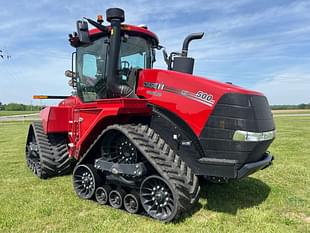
top-left (103, 124), bottom-right (200, 220)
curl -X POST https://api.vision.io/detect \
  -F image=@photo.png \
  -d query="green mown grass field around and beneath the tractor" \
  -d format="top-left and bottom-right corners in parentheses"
top-left (0, 117), bottom-right (310, 233)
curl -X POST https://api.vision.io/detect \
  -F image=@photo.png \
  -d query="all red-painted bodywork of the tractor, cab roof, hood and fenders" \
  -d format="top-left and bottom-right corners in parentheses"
top-left (41, 25), bottom-right (262, 159)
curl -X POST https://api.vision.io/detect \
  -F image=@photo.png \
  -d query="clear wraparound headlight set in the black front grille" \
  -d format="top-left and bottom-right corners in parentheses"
top-left (233, 130), bottom-right (276, 142)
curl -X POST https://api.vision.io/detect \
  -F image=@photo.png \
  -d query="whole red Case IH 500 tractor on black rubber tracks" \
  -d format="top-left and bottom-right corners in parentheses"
top-left (26, 8), bottom-right (275, 221)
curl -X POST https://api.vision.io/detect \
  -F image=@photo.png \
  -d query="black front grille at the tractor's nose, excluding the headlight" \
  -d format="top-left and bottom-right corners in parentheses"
top-left (200, 93), bottom-right (275, 165)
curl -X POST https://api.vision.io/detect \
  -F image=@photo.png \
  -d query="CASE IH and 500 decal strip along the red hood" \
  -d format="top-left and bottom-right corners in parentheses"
top-left (144, 82), bottom-right (215, 107)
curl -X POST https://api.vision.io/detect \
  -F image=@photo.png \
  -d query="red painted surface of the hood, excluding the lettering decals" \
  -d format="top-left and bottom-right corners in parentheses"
top-left (137, 69), bottom-right (262, 136)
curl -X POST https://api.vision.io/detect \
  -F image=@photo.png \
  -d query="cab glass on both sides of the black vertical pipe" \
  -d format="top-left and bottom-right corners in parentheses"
top-left (77, 35), bottom-right (153, 102)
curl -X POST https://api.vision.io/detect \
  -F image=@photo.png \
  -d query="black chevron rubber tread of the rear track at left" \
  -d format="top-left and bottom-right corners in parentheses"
top-left (26, 121), bottom-right (72, 179)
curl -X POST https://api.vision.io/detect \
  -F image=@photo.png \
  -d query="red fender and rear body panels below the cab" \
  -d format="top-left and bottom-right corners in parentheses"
top-left (40, 97), bottom-right (151, 159)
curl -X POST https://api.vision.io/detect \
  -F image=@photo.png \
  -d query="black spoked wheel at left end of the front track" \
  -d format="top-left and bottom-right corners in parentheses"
top-left (73, 164), bottom-right (100, 199)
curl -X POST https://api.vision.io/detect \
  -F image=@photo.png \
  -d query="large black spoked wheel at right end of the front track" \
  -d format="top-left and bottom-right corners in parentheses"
top-left (140, 175), bottom-right (177, 221)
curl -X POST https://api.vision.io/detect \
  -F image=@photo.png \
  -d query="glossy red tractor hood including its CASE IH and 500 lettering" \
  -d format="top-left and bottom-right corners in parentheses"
top-left (136, 69), bottom-right (270, 135)
